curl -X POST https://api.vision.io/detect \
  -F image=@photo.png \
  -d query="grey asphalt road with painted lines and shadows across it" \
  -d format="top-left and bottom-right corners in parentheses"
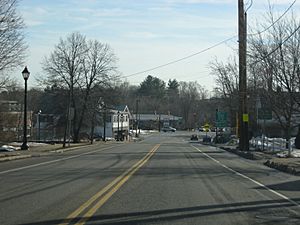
top-left (0, 132), bottom-right (300, 225)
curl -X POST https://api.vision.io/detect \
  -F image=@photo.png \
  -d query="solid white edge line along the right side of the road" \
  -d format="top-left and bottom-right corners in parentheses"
top-left (192, 145), bottom-right (300, 207)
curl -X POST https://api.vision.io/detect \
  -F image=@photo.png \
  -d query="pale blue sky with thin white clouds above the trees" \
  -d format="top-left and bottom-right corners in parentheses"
top-left (14, 0), bottom-right (300, 90)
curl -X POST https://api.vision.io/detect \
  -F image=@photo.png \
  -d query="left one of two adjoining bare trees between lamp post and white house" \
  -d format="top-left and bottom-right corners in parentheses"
top-left (43, 33), bottom-right (88, 146)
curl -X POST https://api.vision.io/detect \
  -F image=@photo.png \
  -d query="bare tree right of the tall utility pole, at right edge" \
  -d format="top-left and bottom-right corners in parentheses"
top-left (249, 8), bottom-right (300, 153)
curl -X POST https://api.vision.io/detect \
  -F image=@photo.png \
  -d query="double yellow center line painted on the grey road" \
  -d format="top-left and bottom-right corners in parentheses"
top-left (60, 144), bottom-right (160, 225)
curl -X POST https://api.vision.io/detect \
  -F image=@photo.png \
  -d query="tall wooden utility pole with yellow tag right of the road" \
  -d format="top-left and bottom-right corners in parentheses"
top-left (238, 0), bottom-right (249, 151)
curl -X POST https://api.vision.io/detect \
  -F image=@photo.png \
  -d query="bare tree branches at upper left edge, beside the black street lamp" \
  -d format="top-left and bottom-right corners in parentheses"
top-left (0, 0), bottom-right (27, 88)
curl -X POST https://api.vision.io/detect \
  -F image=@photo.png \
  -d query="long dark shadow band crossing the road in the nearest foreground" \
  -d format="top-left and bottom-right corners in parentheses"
top-left (22, 199), bottom-right (300, 225)
